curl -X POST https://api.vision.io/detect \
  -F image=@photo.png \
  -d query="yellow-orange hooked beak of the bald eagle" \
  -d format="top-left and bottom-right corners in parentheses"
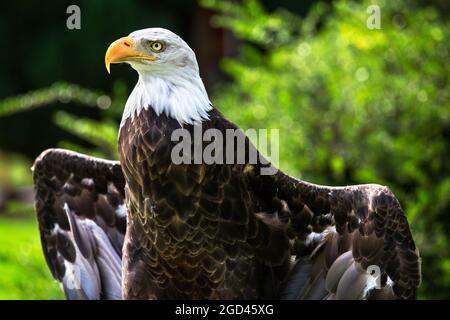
top-left (105, 37), bottom-right (158, 73)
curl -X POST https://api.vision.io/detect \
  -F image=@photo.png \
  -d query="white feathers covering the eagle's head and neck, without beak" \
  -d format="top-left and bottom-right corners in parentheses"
top-left (121, 28), bottom-right (212, 126)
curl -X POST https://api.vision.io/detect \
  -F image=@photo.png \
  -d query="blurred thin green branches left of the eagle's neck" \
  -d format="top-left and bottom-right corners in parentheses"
top-left (0, 82), bottom-right (127, 159)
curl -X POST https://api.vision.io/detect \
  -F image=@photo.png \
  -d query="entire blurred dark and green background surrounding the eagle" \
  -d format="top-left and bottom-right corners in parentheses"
top-left (0, 0), bottom-right (450, 299)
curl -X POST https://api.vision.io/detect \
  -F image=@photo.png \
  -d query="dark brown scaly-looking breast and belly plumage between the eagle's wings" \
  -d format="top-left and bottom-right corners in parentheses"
top-left (119, 108), bottom-right (290, 299)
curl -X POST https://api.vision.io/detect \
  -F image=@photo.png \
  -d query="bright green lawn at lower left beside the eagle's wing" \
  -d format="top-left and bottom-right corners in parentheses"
top-left (0, 217), bottom-right (64, 300)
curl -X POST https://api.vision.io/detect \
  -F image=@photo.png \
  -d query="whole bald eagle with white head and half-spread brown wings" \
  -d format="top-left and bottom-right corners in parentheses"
top-left (33, 28), bottom-right (421, 299)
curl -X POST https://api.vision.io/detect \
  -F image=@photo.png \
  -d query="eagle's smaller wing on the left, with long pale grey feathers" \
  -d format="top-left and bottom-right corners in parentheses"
top-left (33, 149), bottom-right (126, 299)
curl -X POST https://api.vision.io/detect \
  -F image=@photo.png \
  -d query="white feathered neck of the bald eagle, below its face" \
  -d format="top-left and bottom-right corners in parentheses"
top-left (121, 72), bottom-right (212, 127)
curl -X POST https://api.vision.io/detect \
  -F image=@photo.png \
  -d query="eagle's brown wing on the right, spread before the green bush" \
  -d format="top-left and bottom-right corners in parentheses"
top-left (250, 171), bottom-right (421, 299)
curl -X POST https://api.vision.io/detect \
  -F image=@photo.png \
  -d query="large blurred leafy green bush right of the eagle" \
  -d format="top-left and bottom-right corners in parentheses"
top-left (201, 0), bottom-right (450, 298)
